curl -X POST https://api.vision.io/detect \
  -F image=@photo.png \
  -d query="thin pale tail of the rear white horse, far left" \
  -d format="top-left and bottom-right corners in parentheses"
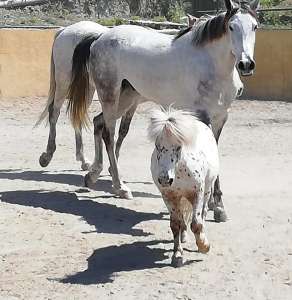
top-left (34, 28), bottom-right (64, 127)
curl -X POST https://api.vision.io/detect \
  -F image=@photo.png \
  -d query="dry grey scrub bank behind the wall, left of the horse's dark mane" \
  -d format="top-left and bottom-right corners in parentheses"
top-left (0, 0), bottom-right (191, 25)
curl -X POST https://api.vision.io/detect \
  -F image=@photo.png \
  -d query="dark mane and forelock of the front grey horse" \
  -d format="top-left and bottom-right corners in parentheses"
top-left (174, 1), bottom-right (257, 46)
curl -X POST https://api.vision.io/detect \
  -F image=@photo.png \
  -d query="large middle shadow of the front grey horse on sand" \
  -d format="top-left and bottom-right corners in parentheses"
top-left (0, 190), bottom-right (164, 236)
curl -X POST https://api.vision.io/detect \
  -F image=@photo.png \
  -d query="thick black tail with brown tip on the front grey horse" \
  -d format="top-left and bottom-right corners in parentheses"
top-left (67, 34), bottom-right (101, 129)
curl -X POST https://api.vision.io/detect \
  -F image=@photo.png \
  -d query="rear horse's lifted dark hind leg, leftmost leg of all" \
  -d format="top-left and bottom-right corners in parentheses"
top-left (39, 90), bottom-right (65, 167)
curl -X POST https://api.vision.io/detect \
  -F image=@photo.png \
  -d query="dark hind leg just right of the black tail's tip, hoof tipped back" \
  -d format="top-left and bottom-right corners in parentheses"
top-left (84, 113), bottom-right (104, 187)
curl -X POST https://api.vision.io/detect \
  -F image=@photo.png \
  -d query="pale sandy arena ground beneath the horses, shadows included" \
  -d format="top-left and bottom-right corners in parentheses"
top-left (0, 98), bottom-right (292, 300)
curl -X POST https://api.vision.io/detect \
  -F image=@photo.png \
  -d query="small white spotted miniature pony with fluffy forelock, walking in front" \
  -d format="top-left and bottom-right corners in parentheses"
top-left (148, 107), bottom-right (219, 267)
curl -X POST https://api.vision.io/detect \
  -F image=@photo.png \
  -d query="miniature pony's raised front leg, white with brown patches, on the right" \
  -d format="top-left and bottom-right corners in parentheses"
top-left (191, 191), bottom-right (210, 253)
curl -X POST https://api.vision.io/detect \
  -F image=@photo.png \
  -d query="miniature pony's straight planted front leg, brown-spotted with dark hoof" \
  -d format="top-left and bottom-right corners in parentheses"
top-left (170, 212), bottom-right (183, 267)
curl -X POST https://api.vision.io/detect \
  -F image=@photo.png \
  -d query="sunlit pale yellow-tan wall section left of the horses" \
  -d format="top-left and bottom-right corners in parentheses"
top-left (0, 29), bottom-right (56, 99)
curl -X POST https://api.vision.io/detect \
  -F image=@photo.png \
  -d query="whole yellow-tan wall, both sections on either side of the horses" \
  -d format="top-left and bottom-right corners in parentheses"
top-left (0, 29), bottom-right (292, 101)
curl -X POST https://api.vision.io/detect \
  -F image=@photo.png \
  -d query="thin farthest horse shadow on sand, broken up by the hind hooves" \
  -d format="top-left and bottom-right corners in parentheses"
top-left (0, 169), bottom-right (161, 198)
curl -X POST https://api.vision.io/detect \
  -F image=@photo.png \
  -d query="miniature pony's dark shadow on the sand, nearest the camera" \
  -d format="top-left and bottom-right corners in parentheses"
top-left (60, 241), bottom-right (172, 285)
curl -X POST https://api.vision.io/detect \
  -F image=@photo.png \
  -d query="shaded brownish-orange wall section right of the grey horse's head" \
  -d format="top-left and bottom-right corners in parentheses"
top-left (243, 30), bottom-right (292, 101)
